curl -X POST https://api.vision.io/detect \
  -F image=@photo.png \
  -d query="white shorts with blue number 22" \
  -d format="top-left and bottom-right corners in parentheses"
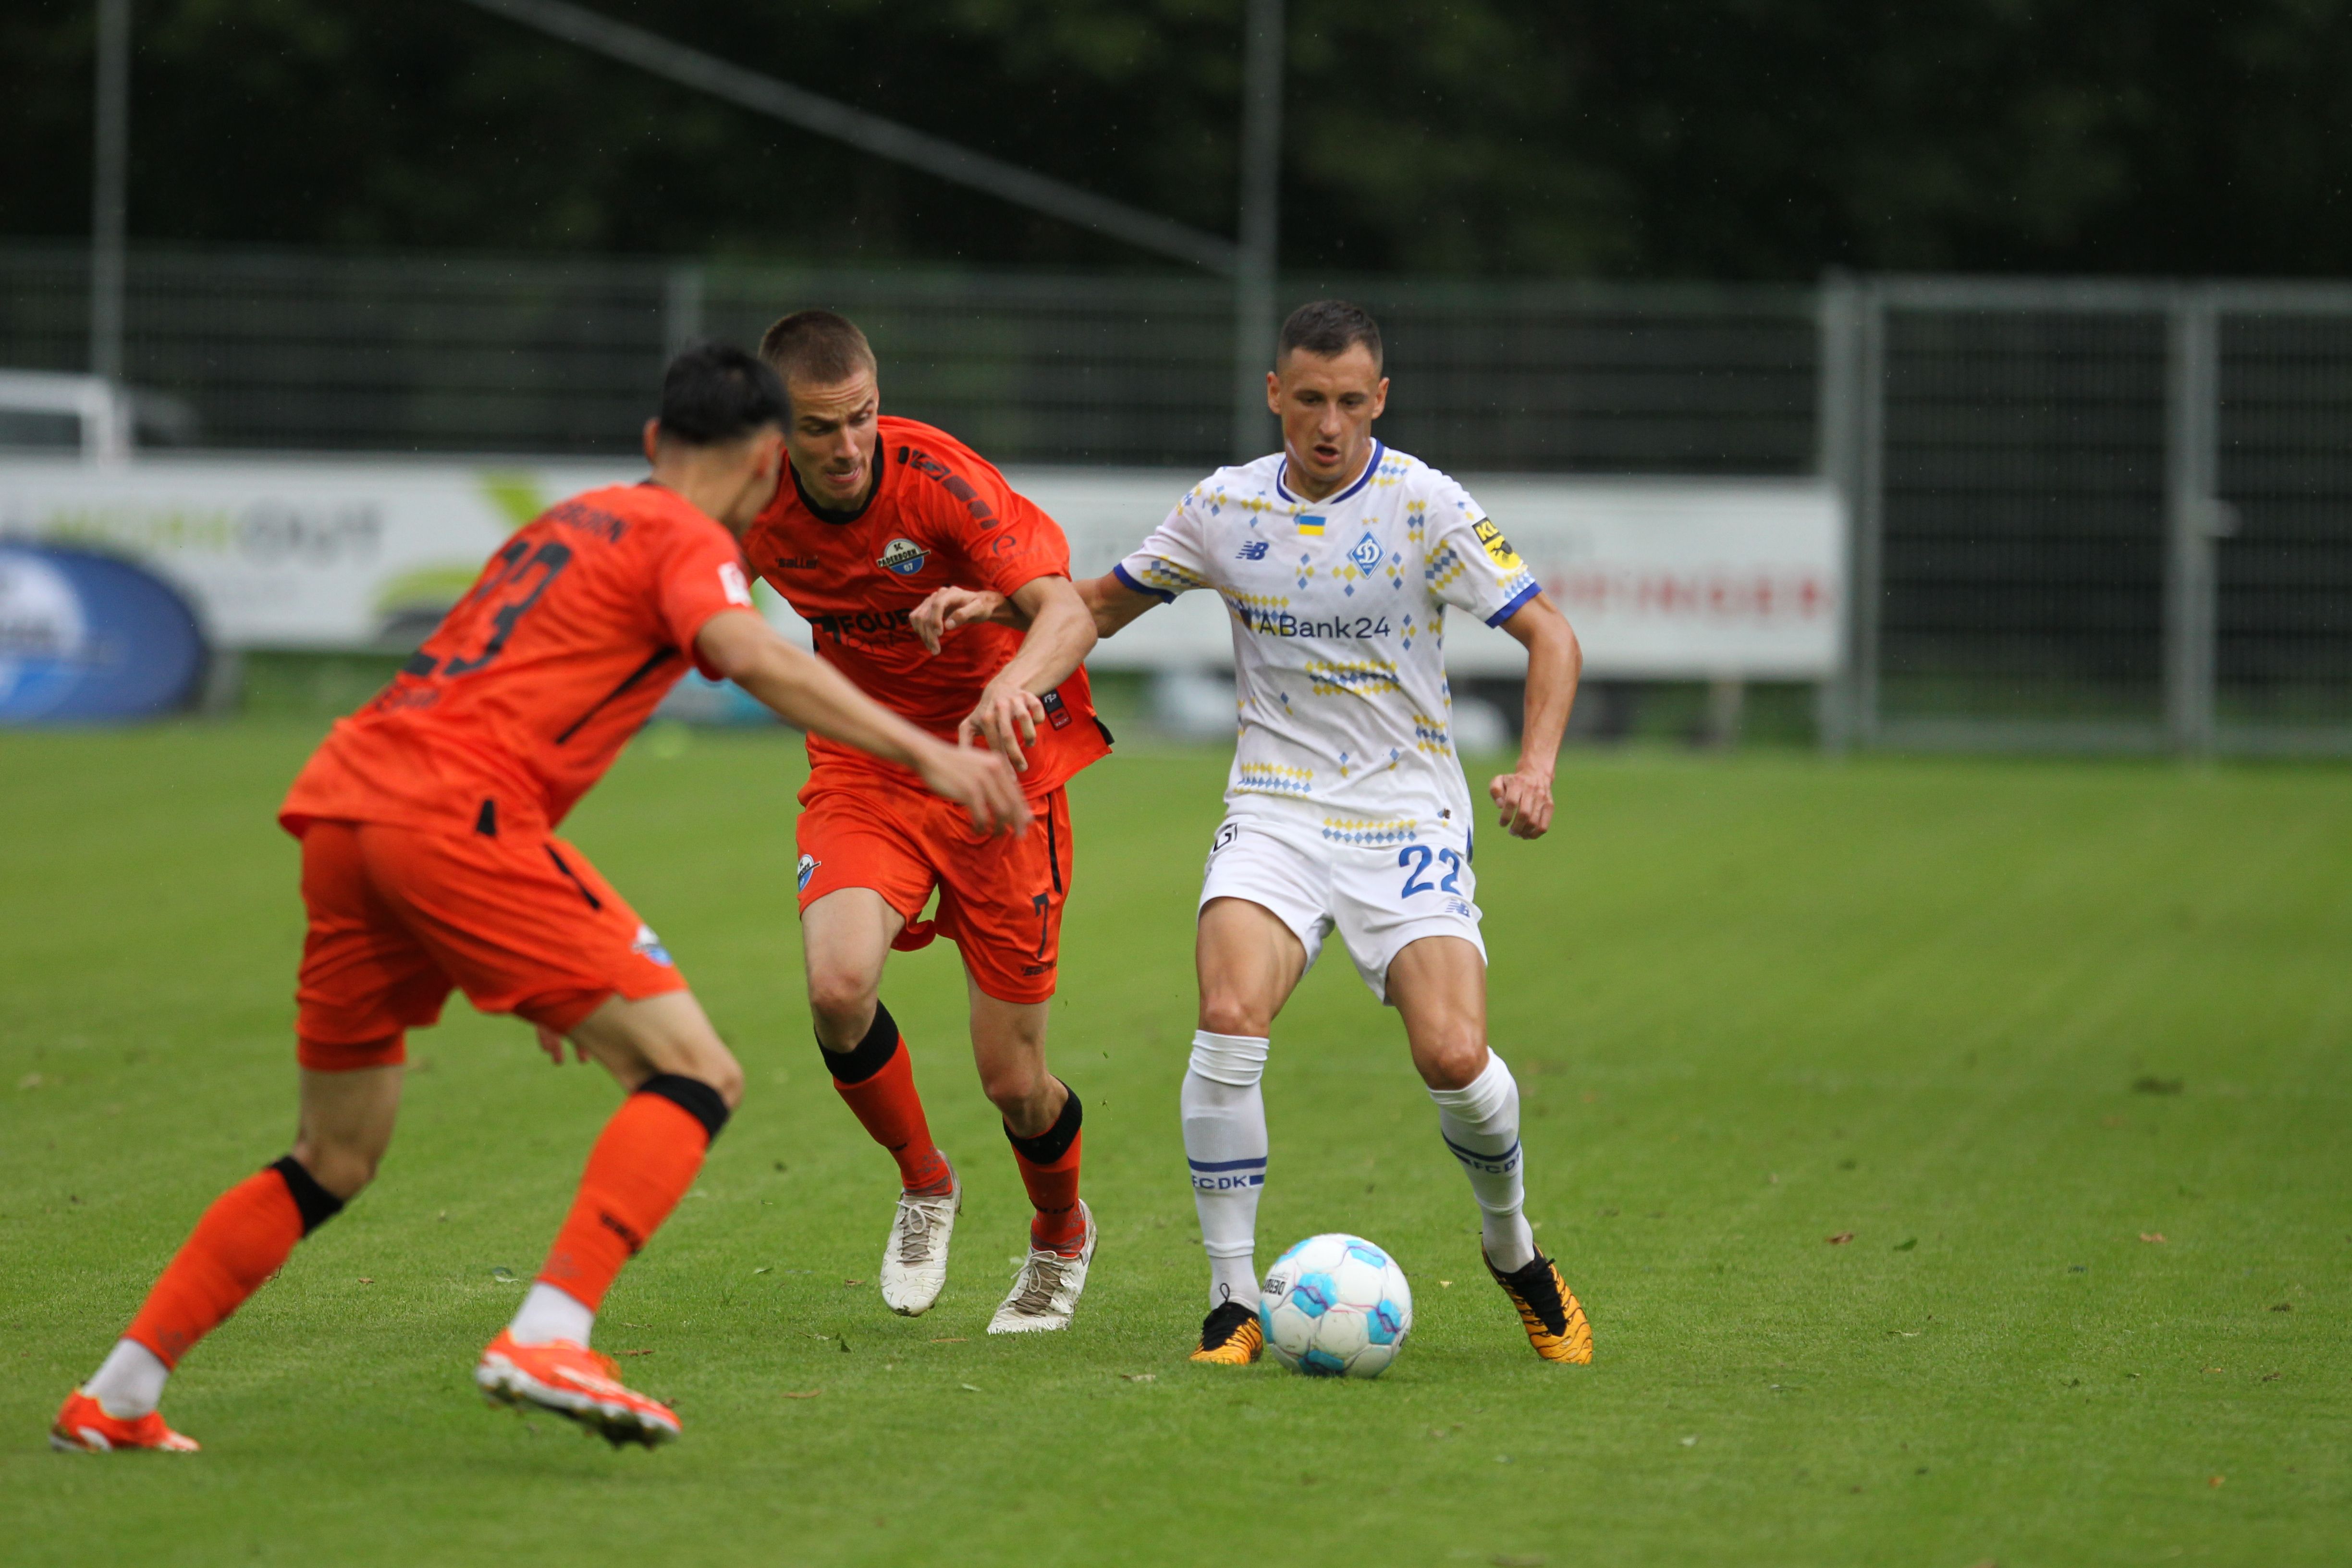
top-left (1200, 802), bottom-right (1486, 1002)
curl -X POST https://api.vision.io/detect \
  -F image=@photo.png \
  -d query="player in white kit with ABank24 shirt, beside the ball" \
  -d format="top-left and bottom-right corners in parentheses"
top-left (915, 301), bottom-right (1592, 1363)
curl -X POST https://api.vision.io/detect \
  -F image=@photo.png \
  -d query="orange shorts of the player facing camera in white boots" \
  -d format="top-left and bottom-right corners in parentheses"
top-left (795, 776), bottom-right (1070, 1002)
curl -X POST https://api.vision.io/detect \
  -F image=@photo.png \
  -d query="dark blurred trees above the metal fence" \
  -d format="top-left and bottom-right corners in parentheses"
top-left (0, 0), bottom-right (2352, 280)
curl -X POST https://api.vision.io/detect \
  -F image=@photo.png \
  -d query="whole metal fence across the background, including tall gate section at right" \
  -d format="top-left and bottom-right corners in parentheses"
top-left (0, 247), bottom-right (2352, 752)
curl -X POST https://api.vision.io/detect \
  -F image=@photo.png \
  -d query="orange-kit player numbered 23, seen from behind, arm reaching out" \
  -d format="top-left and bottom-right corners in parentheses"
top-left (49, 345), bottom-right (1028, 1453)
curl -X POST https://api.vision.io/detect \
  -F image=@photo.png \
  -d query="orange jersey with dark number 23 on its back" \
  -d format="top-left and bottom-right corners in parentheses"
top-left (278, 484), bottom-right (750, 834)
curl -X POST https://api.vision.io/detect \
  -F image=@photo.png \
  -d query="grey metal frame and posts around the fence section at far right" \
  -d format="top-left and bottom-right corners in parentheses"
top-left (1821, 275), bottom-right (2352, 757)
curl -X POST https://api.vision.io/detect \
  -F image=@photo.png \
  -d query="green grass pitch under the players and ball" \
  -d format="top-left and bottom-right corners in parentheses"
top-left (0, 722), bottom-right (2352, 1568)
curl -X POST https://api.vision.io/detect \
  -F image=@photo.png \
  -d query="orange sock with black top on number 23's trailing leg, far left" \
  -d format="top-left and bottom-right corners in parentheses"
top-left (122, 1154), bottom-right (343, 1366)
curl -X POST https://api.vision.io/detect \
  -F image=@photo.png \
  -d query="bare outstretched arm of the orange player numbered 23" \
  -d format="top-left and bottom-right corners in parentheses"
top-left (694, 609), bottom-right (1030, 832)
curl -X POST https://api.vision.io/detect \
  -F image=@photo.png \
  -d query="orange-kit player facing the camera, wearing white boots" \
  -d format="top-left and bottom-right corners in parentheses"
top-left (743, 310), bottom-right (1110, 1333)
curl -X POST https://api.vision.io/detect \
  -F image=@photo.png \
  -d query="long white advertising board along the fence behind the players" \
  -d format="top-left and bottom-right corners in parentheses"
top-left (0, 456), bottom-right (1844, 679)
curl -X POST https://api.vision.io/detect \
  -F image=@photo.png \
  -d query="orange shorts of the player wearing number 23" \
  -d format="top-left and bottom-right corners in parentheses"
top-left (294, 823), bottom-right (687, 1072)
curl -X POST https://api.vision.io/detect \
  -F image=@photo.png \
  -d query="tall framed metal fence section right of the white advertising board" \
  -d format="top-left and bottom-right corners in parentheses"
top-left (1823, 277), bottom-right (2352, 752)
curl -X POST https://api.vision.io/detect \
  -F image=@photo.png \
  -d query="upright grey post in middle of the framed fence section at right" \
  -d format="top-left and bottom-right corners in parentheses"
top-left (2164, 289), bottom-right (2223, 757)
